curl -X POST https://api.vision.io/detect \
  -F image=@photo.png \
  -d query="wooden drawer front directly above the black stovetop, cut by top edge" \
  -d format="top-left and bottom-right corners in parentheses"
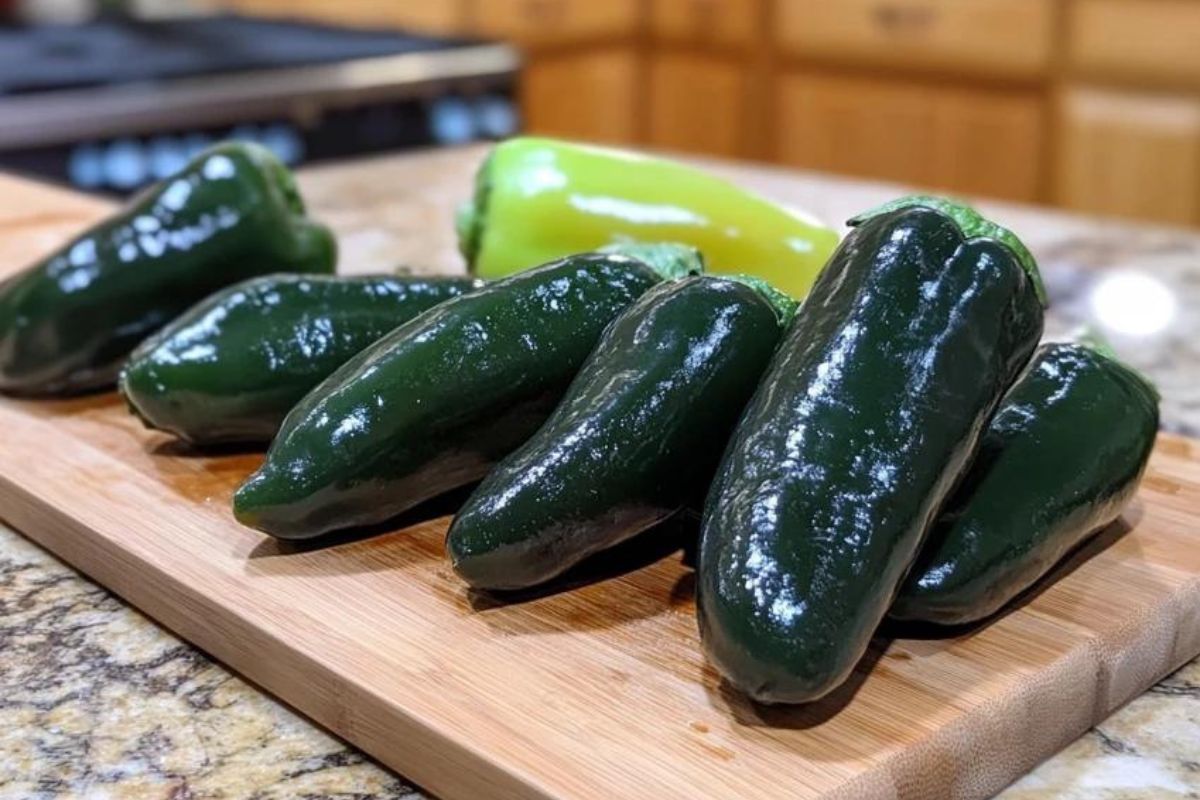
top-left (213, 0), bottom-right (467, 34)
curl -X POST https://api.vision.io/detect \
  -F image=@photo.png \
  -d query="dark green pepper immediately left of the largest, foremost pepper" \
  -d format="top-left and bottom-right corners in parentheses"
top-left (446, 276), bottom-right (781, 590)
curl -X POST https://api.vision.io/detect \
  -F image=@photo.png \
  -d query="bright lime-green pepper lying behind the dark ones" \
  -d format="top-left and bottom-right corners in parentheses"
top-left (458, 138), bottom-right (838, 299)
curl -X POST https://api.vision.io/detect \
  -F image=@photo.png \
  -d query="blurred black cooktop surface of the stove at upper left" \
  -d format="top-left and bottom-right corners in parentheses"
top-left (0, 16), bottom-right (473, 95)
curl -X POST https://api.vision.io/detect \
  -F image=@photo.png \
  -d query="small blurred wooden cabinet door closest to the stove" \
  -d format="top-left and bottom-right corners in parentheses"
top-left (521, 47), bottom-right (637, 143)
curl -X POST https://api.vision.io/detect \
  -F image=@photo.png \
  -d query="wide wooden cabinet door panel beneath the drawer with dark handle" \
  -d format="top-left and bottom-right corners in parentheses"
top-left (776, 73), bottom-right (1044, 200)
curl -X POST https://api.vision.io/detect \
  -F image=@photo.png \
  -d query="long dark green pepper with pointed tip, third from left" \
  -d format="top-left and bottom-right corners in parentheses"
top-left (234, 247), bottom-right (700, 539)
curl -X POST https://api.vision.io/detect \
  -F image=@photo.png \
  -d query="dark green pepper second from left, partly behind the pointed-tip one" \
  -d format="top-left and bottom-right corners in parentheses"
top-left (120, 273), bottom-right (482, 445)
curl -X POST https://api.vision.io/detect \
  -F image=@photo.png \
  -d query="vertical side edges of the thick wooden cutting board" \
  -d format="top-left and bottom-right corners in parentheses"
top-left (0, 395), bottom-right (1200, 800)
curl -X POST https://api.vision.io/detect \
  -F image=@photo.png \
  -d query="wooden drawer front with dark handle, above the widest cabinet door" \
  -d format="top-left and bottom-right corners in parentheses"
top-left (776, 0), bottom-right (1055, 77)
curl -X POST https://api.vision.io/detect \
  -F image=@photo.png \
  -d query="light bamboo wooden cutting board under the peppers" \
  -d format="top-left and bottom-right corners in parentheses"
top-left (0, 172), bottom-right (1200, 800)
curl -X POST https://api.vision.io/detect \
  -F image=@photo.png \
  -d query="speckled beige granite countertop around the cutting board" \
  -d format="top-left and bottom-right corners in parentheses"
top-left (0, 151), bottom-right (1200, 800)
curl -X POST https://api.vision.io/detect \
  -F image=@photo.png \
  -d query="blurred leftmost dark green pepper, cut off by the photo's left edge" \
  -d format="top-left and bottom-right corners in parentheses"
top-left (0, 143), bottom-right (336, 395)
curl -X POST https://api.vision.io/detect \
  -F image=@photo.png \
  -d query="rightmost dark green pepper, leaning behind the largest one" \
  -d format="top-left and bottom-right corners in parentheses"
top-left (890, 344), bottom-right (1158, 625)
